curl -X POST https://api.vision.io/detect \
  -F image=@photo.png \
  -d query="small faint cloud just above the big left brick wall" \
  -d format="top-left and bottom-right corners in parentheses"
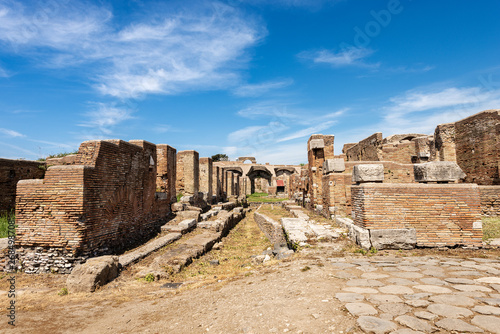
top-left (79, 103), bottom-right (133, 134)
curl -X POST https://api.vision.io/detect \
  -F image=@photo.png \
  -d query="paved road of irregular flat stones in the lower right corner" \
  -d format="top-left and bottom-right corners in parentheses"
top-left (331, 256), bottom-right (500, 334)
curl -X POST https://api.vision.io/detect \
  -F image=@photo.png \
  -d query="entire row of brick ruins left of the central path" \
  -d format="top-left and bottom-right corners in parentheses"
top-left (0, 140), bottom-right (248, 273)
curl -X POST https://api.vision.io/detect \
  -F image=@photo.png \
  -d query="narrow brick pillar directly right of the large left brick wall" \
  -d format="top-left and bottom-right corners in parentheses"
top-left (156, 144), bottom-right (177, 203)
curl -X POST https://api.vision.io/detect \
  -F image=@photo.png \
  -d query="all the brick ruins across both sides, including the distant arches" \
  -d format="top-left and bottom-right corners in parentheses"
top-left (0, 110), bottom-right (500, 273)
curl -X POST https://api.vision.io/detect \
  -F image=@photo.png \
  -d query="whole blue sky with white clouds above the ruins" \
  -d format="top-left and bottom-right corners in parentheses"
top-left (0, 0), bottom-right (500, 164)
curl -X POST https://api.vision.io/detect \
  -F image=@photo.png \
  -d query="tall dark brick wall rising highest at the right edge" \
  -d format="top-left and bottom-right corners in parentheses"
top-left (455, 110), bottom-right (500, 185)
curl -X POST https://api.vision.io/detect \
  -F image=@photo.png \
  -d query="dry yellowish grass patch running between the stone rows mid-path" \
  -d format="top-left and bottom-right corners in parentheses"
top-left (170, 211), bottom-right (273, 286)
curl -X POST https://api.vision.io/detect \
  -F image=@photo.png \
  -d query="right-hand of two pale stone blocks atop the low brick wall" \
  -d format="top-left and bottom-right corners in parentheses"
top-left (413, 161), bottom-right (466, 182)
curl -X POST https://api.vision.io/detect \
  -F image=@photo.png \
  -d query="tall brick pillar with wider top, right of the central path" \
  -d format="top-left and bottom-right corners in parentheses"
top-left (307, 135), bottom-right (334, 209)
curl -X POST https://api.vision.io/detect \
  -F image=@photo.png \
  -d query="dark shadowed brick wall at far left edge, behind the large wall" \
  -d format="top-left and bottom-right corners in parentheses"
top-left (0, 158), bottom-right (46, 214)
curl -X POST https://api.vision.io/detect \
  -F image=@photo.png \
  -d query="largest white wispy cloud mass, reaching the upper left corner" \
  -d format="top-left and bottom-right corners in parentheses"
top-left (0, 0), bottom-right (266, 98)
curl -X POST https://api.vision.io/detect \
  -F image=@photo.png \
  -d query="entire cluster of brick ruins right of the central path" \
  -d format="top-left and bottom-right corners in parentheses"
top-left (289, 110), bottom-right (500, 248)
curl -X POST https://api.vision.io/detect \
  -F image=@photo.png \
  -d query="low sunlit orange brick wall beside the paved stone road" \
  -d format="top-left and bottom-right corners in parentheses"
top-left (351, 183), bottom-right (482, 246)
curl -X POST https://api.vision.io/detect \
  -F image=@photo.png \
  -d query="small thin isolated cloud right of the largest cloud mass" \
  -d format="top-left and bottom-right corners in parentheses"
top-left (298, 47), bottom-right (379, 67)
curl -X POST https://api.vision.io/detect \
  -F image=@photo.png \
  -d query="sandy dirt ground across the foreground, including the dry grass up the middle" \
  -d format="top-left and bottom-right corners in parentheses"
top-left (0, 206), bottom-right (500, 334)
